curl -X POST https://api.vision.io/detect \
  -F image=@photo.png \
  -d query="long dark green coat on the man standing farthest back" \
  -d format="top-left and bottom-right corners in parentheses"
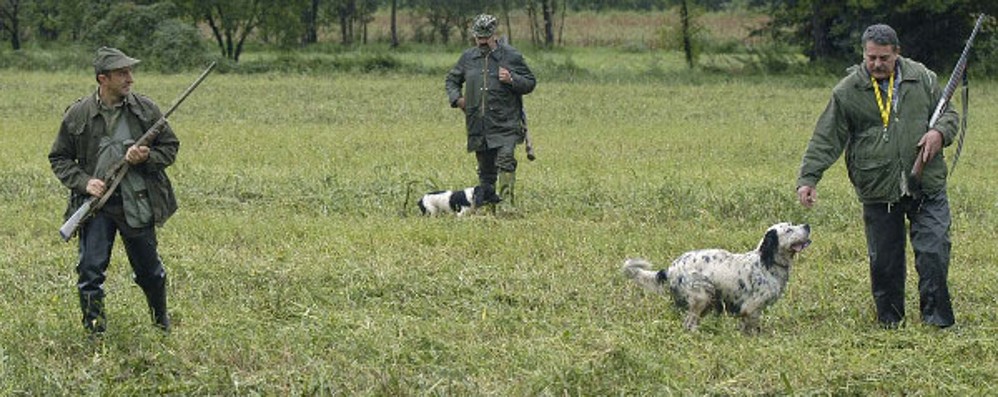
top-left (445, 44), bottom-right (537, 152)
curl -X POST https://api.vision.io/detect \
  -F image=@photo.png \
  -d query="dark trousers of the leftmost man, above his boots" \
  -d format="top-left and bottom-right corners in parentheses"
top-left (76, 202), bottom-right (166, 299)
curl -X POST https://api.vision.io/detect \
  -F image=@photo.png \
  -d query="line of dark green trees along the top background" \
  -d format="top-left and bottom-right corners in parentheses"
top-left (0, 0), bottom-right (998, 73)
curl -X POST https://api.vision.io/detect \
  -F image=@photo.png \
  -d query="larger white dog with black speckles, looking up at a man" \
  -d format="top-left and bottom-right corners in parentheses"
top-left (621, 223), bottom-right (811, 334)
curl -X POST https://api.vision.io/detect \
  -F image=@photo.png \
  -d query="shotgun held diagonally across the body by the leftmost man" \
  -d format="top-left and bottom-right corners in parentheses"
top-left (59, 62), bottom-right (215, 241)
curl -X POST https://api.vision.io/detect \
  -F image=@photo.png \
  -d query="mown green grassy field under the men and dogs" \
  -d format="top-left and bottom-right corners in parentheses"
top-left (0, 48), bottom-right (998, 395)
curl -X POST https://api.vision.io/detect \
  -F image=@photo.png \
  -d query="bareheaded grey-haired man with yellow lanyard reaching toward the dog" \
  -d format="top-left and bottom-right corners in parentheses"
top-left (797, 24), bottom-right (958, 328)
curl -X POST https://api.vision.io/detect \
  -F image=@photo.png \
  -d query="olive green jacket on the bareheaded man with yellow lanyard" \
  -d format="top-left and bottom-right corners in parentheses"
top-left (797, 57), bottom-right (958, 203)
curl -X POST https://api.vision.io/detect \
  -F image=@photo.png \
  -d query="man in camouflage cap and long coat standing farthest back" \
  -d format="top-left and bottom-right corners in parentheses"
top-left (445, 14), bottom-right (536, 206)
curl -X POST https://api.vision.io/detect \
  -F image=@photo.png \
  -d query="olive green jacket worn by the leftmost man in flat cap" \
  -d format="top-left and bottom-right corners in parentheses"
top-left (48, 93), bottom-right (180, 226)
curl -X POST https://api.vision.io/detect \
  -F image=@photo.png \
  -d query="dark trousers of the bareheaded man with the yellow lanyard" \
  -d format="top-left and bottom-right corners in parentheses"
top-left (863, 192), bottom-right (955, 327)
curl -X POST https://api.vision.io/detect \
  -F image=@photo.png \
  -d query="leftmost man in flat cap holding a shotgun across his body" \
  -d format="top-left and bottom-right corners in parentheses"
top-left (48, 47), bottom-right (180, 335)
